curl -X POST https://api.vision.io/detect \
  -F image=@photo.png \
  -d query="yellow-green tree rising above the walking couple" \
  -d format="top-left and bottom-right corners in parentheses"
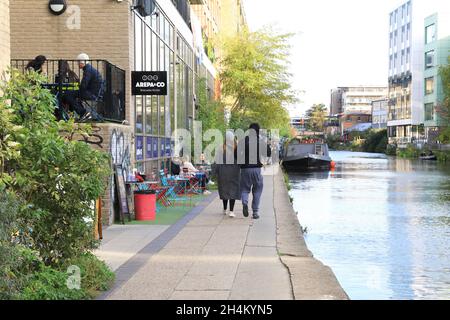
top-left (220, 29), bottom-right (296, 134)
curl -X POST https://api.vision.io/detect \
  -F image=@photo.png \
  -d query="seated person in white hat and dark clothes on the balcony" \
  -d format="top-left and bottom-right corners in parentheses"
top-left (64, 53), bottom-right (103, 118)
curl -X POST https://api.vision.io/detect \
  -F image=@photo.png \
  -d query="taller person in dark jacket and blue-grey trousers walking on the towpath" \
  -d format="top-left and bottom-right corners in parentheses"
top-left (238, 123), bottom-right (272, 219)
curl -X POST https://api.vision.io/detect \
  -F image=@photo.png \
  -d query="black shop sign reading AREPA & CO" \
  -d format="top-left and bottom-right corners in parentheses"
top-left (131, 71), bottom-right (167, 96)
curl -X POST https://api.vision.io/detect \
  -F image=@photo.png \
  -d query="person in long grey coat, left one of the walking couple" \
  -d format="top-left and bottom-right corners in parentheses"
top-left (212, 131), bottom-right (241, 218)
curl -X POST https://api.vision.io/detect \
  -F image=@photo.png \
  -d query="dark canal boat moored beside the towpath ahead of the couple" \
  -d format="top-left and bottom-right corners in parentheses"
top-left (281, 136), bottom-right (333, 171)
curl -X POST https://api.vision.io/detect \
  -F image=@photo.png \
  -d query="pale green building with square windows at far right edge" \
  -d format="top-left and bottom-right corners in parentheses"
top-left (423, 10), bottom-right (450, 141)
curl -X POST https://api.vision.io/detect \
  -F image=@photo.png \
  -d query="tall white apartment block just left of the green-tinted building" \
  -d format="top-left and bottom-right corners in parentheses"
top-left (388, 0), bottom-right (448, 144)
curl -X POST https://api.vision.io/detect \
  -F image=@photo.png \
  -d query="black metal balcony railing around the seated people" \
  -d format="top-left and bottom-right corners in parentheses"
top-left (11, 59), bottom-right (125, 122)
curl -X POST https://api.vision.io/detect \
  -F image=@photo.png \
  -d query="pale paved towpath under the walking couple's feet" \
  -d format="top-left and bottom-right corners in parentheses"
top-left (98, 168), bottom-right (293, 300)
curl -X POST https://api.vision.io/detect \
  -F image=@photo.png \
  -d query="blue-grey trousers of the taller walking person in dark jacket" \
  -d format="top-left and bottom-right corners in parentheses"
top-left (241, 168), bottom-right (264, 214)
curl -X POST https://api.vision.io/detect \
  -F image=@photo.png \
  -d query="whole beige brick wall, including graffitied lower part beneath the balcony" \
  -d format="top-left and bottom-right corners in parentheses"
top-left (10, 0), bottom-right (134, 225)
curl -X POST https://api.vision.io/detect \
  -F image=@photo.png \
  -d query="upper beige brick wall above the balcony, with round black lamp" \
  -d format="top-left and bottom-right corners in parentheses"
top-left (10, 0), bottom-right (133, 122)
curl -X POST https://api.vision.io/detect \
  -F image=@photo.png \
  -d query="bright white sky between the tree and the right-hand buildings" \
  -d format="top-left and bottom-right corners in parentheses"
top-left (243, 0), bottom-right (402, 116)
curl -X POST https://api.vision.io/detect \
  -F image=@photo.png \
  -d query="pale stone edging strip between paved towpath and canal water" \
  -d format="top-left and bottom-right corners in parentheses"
top-left (273, 168), bottom-right (349, 300)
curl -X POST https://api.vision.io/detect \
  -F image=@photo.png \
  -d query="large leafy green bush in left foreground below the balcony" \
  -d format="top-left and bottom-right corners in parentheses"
top-left (0, 71), bottom-right (110, 265)
